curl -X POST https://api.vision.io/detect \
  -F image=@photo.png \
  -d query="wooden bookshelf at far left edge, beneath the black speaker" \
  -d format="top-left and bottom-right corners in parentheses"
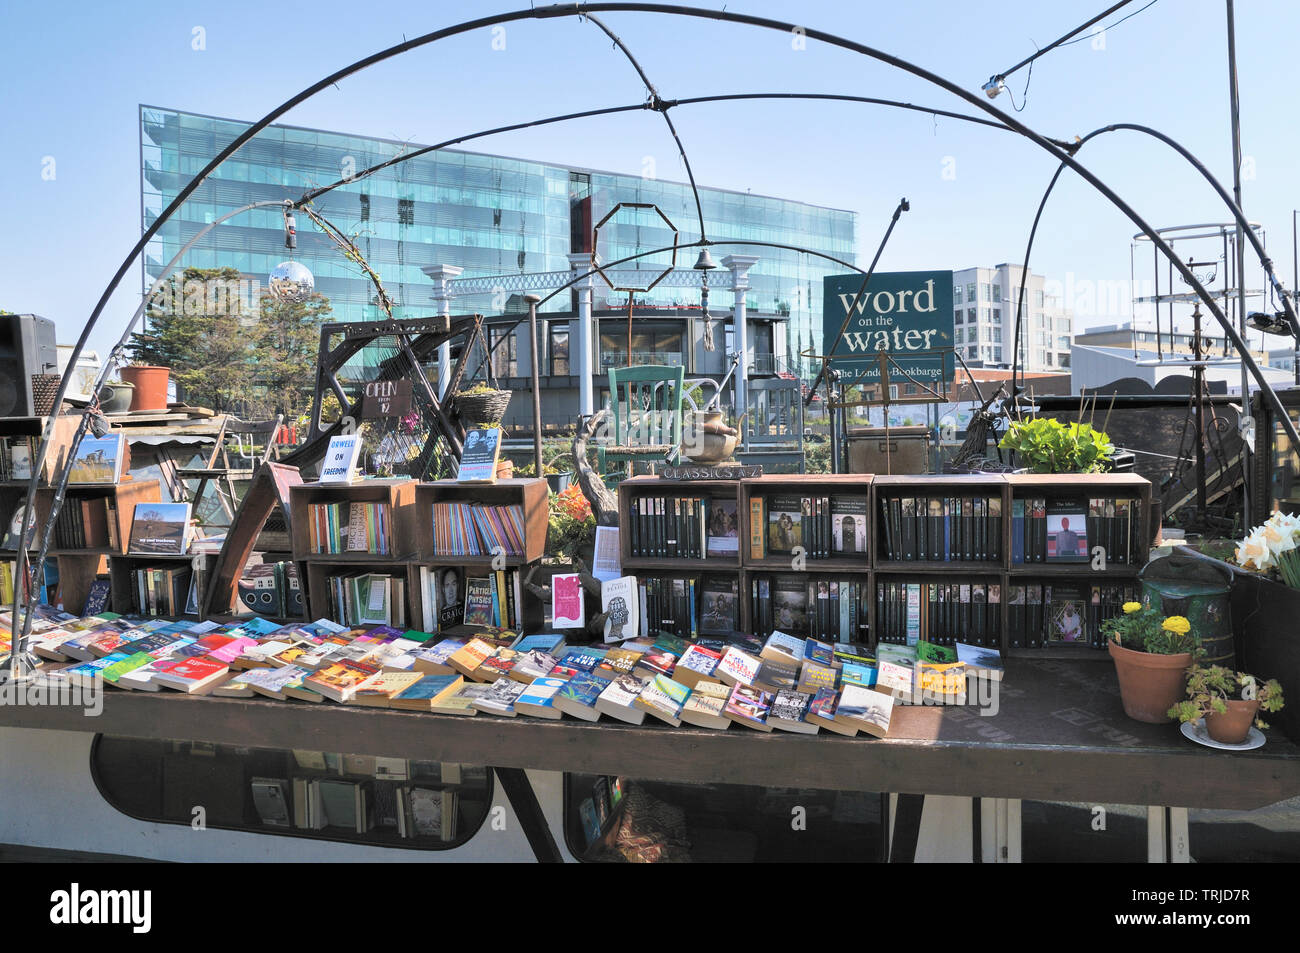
top-left (0, 415), bottom-right (161, 614)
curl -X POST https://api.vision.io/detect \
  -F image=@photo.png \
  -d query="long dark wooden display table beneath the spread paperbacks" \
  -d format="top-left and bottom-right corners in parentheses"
top-left (0, 659), bottom-right (1300, 810)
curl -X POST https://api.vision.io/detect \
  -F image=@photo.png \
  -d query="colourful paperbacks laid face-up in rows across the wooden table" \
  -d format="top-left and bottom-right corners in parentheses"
top-left (0, 610), bottom-right (1001, 735)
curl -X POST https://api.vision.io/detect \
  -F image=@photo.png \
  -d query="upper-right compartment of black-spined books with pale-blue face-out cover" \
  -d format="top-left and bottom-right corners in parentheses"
top-left (1011, 497), bottom-right (1147, 566)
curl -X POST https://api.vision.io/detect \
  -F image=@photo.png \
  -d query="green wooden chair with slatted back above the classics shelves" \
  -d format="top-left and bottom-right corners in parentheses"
top-left (597, 365), bottom-right (686, 476)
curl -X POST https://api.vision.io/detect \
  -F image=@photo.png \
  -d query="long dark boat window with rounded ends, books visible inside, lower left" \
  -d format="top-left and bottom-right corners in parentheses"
top-left (90, 735), bottom-right (493, 850)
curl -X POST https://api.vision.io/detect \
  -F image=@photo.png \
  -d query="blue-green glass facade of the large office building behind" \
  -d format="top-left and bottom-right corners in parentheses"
top-left (140, 105), bottom-right (857, 369)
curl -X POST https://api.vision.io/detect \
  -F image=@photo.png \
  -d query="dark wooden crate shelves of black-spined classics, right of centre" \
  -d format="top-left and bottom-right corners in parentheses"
top-left (619, 473), bottom-right (1153, 658)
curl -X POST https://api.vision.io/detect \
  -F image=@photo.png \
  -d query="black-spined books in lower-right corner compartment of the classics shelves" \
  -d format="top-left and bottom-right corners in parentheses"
top-left (1006, 582), bottom-right (1141, 649)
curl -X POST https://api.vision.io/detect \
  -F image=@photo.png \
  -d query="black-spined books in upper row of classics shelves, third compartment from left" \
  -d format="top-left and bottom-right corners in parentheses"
top-left (880, 495), bottom-right (1002, 563)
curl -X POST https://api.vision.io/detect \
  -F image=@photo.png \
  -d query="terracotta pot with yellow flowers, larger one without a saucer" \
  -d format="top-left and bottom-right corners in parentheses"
top-left (1101, 602), bottom-right (1197, 724)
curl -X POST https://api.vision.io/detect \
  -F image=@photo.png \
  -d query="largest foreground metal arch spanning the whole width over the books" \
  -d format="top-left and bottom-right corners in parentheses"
top-left (12, 3), bottom-right (1300, 675)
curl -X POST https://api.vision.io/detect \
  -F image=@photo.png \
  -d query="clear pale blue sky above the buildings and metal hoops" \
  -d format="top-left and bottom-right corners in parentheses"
top-left (0, 0), bottom-right (1300, 361)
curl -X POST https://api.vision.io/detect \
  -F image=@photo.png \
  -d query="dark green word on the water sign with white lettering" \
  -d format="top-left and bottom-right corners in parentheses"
top-left (822, 272), bottom-right (953, 384)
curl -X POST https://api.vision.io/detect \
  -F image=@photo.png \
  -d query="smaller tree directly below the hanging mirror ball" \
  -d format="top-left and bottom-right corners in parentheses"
top-left (252, 294), bottom-right (330, 421)
